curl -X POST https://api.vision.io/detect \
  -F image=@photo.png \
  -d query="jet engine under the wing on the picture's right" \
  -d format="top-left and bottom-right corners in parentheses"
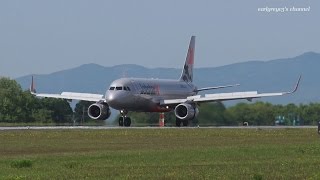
top-left (174, 103), bottom-right (199, 120)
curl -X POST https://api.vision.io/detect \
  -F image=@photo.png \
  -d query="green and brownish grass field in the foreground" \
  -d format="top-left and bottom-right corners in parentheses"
top-left (0, 128), bottom-right (320, 179)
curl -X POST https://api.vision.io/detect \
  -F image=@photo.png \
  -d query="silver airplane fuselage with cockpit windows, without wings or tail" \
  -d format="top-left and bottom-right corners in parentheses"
top-left (105, 78), bottom-right (196, 112)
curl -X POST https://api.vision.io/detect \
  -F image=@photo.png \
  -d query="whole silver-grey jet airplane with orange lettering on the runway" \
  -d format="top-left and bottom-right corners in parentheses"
top-left (30, 36), bottom-right (301, 126)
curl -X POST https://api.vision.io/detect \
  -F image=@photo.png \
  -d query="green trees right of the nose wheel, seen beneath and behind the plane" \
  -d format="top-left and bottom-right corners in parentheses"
top-left (124, 102), bottom-right (320, 126)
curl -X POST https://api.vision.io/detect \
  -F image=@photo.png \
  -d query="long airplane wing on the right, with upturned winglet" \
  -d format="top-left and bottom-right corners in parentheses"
top-left (160, 76), bottom-right (301, 105)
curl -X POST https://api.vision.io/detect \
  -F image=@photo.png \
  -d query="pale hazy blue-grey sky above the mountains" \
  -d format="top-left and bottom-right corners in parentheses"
top-left (0, 0), bottom-right (320, 78)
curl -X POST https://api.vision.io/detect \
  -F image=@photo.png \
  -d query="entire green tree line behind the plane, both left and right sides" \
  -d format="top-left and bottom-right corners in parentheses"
top-left (0, 78), bottom-right (320, 126)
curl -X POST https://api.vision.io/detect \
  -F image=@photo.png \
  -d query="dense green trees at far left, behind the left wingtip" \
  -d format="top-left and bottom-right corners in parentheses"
top-left (0, 78), bottom-right (73, 123)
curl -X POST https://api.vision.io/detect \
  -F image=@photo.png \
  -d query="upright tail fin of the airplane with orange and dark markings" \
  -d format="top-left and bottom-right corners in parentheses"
top-left (180, 36), bottom-right (196, 82)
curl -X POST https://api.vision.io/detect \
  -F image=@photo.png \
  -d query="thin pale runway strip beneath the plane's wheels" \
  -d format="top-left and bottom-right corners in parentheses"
top-left (0, 126), bottom-right (317, 131)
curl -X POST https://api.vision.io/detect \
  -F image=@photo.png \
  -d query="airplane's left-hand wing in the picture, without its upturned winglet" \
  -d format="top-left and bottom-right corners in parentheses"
top-left (31, 92), bottom-right (104, 102)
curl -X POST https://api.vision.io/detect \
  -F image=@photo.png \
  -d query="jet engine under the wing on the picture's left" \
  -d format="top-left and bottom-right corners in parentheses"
top-left (88, 102), bottom-right (111, 120)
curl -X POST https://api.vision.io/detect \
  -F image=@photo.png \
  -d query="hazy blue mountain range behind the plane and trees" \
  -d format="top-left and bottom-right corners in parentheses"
top-left (16, 52), bottom-right (320, 104)
